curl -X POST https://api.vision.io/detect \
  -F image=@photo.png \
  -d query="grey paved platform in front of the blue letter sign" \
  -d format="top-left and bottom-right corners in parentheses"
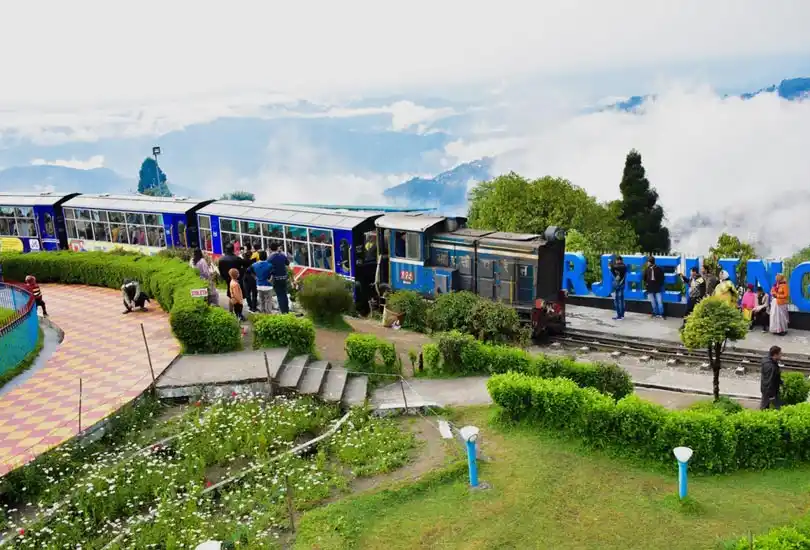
top-left (565, 306), bottom-right (810, 355)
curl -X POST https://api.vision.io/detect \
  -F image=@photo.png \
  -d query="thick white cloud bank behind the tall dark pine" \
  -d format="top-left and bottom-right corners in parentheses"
top-left (447, 88), bottom-right (810, 256)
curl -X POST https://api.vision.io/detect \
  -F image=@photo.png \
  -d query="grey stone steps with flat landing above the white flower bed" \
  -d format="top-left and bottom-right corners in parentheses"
top-left (156, 348), bottom-right (368, 407)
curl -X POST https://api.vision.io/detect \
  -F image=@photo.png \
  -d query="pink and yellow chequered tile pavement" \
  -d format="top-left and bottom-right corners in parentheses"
top-left (0, 285), bottom-right (180, 476)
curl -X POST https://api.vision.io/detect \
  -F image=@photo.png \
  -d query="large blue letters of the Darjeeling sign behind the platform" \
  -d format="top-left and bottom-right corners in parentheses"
top-left (562, 252), bottom-right (810, 311)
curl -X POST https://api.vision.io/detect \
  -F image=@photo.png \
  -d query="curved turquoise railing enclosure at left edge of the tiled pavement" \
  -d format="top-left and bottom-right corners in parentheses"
top-left (0, 283), bottom-right (39, 374)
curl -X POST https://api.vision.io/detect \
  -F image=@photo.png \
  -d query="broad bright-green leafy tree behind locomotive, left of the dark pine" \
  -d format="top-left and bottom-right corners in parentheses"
top-left (468, 172), bottom-right (637, 252)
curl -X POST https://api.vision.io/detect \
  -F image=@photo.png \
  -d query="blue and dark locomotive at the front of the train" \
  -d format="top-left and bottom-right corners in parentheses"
top-left (376, 214), bottom-right (565, 336)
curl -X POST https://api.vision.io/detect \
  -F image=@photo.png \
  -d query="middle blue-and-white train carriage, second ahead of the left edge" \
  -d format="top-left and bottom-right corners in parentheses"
top-left (63, 193), bottom-right (213, 254)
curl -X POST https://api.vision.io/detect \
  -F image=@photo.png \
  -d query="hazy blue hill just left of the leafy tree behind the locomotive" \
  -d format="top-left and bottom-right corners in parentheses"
top-left (383, 158), bottom-right (493, 210)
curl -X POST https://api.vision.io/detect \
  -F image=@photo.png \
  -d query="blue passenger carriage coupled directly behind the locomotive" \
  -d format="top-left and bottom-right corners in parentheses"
top-left (197, 201), bottom-right (382, 306)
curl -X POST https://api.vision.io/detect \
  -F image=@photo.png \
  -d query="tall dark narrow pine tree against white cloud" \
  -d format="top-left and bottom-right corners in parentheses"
top-left (619, 149), bottom-right (670, 254)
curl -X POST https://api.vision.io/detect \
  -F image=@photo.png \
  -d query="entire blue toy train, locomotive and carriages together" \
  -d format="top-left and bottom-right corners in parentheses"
top-left (0, 193), bottom-right (565, 333)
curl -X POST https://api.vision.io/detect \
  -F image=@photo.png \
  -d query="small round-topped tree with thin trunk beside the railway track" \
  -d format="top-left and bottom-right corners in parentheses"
top-left (681, 297), bottom-right (748, 401)
